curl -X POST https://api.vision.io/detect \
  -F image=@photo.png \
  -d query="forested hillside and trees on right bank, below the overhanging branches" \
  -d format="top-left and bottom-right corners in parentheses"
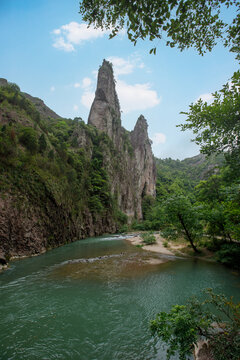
top-left (137, 154), bottom-right (240, 267)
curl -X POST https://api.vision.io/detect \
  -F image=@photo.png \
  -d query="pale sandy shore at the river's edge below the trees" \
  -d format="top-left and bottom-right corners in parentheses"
top-left (126, 234), bottom-right (183, 256)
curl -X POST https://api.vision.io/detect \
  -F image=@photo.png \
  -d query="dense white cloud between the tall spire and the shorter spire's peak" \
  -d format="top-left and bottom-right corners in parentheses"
top-left (116, 80), bottom-right (161, 113)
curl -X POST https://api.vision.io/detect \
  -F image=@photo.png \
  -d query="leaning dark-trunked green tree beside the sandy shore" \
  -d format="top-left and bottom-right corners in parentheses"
top-left (164, 195), bottom-right (202, 252)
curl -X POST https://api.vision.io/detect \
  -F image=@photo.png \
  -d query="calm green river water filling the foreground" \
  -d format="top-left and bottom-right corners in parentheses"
top-left (0, 236), bottom-right (240, 360)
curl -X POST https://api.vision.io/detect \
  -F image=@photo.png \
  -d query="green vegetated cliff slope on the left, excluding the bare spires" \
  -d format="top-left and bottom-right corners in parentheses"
top-left (0, 84), bottom-right (127, 256)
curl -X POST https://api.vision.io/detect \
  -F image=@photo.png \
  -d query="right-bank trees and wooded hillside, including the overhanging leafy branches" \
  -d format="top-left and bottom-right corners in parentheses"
top-left (133, 72), bottom-right (240, 269)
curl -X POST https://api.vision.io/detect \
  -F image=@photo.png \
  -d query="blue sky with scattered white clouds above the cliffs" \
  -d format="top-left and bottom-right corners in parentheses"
top-left (0, 0), bottom-right (238, 159)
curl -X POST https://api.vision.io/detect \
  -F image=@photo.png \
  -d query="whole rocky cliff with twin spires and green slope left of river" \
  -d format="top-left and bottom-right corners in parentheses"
top-left (0, 61), bottom-right (156, 258)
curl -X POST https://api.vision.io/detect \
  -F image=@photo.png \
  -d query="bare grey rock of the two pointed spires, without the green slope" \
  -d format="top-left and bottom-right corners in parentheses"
top-left (88, 60), bottom-right (156, 219)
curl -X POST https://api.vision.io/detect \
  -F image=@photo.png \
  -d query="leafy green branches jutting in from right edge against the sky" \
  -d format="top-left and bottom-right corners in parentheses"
top-left (178, 71), bottom-right (240, 173)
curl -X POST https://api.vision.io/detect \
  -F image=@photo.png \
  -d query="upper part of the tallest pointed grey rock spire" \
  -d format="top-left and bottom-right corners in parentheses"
top-left (88, 60), bottom-right (121, 139)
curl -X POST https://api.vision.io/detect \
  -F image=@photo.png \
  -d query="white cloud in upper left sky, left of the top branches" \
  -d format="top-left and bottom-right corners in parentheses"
top-left (52, 21), bottom-right (110, 52)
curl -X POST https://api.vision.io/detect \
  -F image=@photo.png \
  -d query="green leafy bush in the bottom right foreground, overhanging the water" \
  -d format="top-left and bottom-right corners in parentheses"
top-left (150, 289), bottom-right (240, 360)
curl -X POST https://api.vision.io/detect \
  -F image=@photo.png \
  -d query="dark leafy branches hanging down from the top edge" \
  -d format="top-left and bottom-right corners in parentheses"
top-left (80, 0), bottom-right (240, 56)
